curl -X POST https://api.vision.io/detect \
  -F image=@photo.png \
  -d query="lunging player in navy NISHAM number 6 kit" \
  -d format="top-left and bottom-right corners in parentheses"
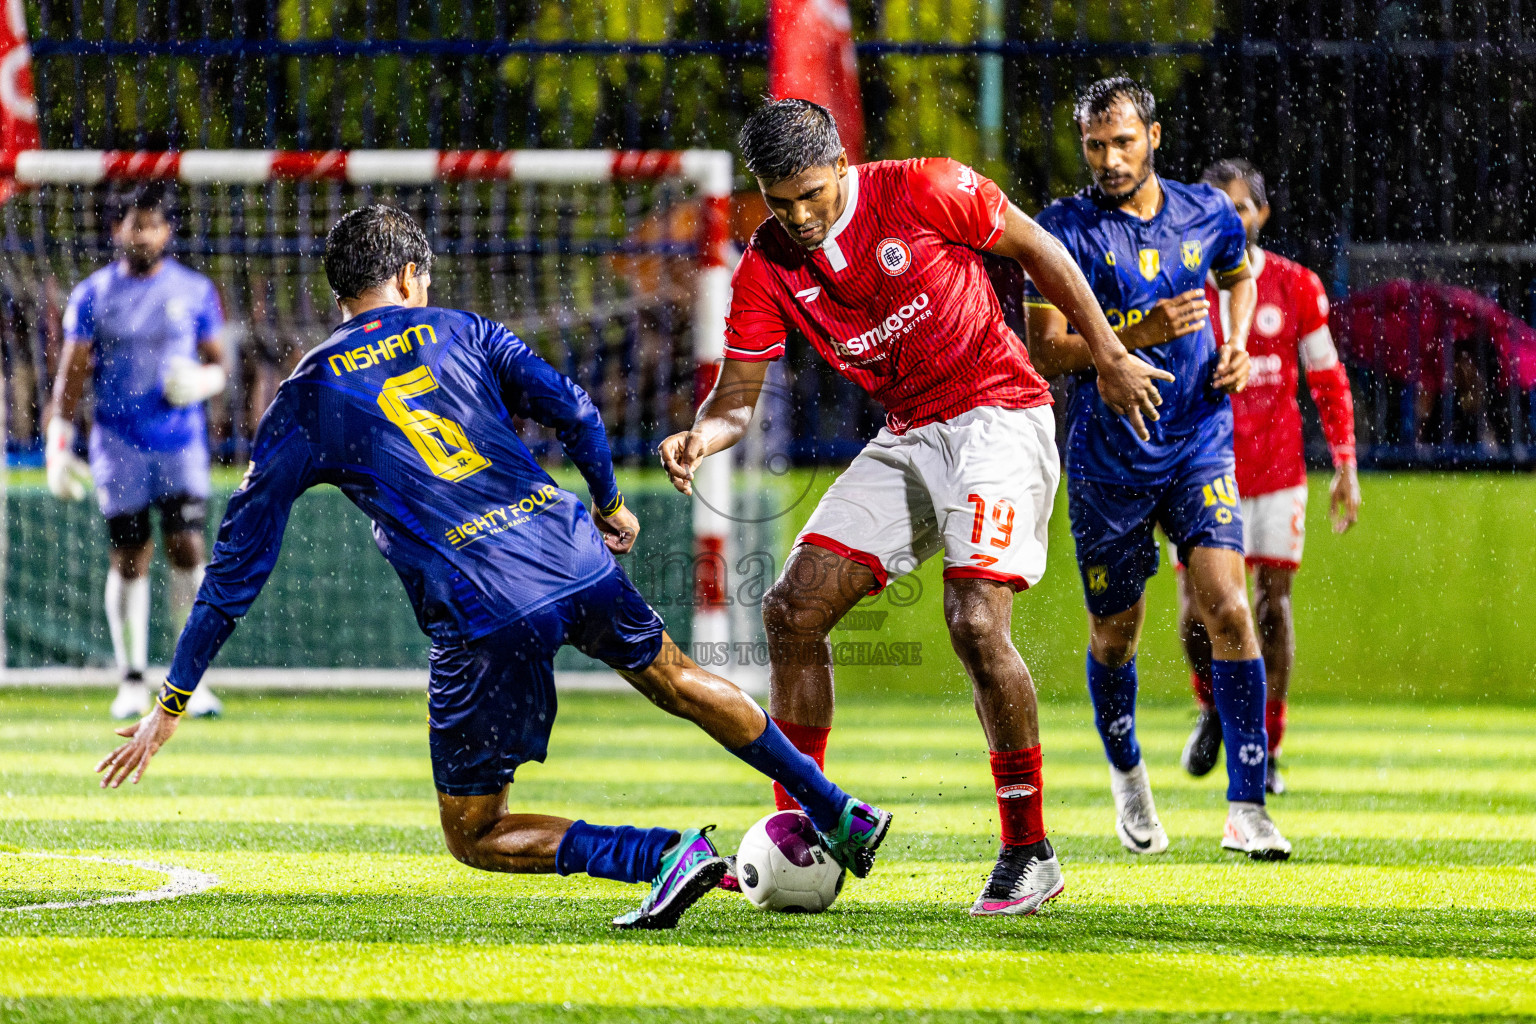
top-left (97, 206), bottom-right (891, 927)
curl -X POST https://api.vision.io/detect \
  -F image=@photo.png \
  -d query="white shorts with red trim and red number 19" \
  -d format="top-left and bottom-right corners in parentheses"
top-left (796, 405), bottom-right (1061, 594)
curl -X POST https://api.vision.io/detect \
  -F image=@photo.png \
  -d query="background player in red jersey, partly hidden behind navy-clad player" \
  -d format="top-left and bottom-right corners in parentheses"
top-left (1178, 160), bottom-right (1359, 794)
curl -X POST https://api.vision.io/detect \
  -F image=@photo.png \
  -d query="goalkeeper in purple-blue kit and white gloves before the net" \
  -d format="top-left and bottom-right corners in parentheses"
top-left (46, 183), bottom-right (224, 718)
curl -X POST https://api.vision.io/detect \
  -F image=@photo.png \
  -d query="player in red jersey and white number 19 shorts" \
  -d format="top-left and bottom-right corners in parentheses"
top-left (660, 100), bottom-right (1172, 915)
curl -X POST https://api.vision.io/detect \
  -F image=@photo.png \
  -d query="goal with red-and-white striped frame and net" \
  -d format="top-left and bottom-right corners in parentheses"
top-left (0, 150), bottom-right (768, 680)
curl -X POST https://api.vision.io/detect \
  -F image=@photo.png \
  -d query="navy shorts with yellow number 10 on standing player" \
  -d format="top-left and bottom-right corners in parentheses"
top-left (1066, 465), bottom-right (1243, 617)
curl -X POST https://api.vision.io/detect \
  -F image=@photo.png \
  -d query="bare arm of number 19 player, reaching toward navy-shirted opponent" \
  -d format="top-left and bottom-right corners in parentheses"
top-left (992, 204), bottom-right (1174, 441)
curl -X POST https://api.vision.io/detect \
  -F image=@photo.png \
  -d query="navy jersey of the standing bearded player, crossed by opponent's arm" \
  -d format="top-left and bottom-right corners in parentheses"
top-left (1025, 178), bottom-right (1247, 485)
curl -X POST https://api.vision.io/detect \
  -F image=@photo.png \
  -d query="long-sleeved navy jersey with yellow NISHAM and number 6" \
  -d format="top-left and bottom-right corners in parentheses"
top-left (170, 306), bottom-right (619, 691)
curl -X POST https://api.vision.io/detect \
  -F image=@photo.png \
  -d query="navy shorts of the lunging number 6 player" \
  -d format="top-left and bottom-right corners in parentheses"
top-left (427, 565), bottom-right (665, 797)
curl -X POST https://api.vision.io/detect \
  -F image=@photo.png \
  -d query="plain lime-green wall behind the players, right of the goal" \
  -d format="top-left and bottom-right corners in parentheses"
top-left (764, 470), bottom-right (1536, 706)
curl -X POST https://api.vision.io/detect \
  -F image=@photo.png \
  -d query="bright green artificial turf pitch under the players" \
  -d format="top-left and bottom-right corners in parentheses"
top-left (0, 689), bottom-right (1536, 1024)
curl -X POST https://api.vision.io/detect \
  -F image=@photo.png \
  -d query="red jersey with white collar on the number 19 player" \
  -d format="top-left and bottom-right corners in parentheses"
top-left (725, 158), bottom-right (1051, 433)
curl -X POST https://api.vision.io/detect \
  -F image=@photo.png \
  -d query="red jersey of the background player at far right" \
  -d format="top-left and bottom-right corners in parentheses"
top-left (1206, 250), bottom-right (1355, 497)
